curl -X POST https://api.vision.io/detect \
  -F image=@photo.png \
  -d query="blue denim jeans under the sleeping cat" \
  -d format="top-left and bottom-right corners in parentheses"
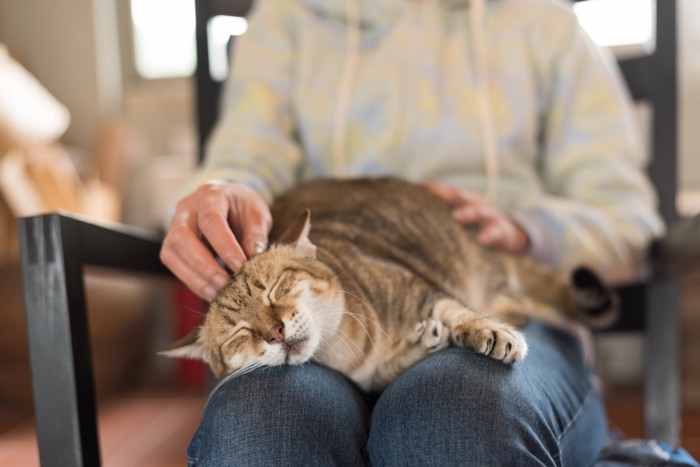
top-left (188, 323), bottom-right (607, 467)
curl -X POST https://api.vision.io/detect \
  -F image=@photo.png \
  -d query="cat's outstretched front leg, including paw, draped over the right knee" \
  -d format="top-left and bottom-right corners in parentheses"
top-left (432, 299), bottom-right (527, 363)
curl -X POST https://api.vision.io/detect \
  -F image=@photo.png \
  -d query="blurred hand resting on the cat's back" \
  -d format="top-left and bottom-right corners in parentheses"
top-left (426, 181), bottom-right (530, 253)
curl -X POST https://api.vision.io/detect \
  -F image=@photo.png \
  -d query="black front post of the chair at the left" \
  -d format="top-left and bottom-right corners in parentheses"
top-left (18, 214), bottom-right (100, 466)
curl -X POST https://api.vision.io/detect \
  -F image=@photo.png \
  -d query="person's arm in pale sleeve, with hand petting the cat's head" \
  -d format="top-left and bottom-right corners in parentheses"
top-left (161, 0), bottom-right (301, 300)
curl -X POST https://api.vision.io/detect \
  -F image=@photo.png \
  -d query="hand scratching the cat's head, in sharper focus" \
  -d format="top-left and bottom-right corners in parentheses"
top-left (160, 182), bottom-right (272, 301)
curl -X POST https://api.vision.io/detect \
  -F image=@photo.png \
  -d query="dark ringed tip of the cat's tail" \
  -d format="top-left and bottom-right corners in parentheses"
top-left (570, 267), bottom-right (620, 329)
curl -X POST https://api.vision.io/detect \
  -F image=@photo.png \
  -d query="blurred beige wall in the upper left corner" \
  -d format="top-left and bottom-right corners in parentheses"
top-left (0, 0), bottom-right (122, 147)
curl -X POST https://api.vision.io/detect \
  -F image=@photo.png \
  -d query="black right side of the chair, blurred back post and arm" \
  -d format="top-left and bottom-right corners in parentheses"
top-left (575, 0), bottom-right (680, 450)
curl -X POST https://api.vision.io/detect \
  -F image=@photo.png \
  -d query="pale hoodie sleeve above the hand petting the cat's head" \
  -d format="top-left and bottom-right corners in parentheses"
top-left (188, 1), bottom-right (301, 202)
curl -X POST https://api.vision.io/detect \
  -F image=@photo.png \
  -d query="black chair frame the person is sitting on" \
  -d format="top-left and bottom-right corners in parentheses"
top-left (19, 0), bottom-right (700, 466)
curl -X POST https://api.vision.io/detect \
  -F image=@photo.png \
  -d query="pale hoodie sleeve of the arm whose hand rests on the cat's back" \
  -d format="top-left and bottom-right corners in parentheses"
top-left (513, 6), bottom-right (663, 282)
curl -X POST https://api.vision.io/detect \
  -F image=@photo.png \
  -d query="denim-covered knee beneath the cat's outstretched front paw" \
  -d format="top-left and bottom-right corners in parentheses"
top-left (368, 349), bottom-right (556, 465)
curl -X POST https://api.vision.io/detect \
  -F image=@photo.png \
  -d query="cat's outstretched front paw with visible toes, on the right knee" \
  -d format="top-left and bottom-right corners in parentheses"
top-left (452, 320), bottom-right (527, 363)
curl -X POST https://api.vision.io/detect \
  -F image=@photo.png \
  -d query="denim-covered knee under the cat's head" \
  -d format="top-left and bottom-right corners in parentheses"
top-left (188, 365), bottom-right (367, 465)
